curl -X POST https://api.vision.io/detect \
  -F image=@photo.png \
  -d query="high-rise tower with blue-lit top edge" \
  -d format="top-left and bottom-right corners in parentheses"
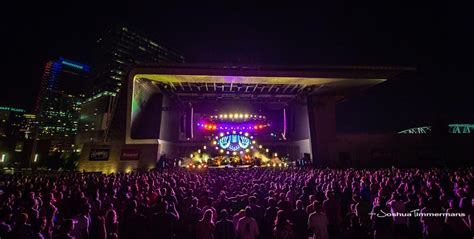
top-left (35, 57), bottom-right (91, 152)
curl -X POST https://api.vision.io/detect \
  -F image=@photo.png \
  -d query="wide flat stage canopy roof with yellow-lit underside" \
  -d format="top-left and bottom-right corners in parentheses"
top-left (130, 65), bottom-right (414, 100)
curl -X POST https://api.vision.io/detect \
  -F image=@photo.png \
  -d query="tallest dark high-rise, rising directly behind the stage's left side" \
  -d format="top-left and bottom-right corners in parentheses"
top-left (76, 26), bottom-right (184, 145)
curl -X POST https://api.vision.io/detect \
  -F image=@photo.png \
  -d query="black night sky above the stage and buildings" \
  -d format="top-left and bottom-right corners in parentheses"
top-left (0, 1), bottom-right (474, 132)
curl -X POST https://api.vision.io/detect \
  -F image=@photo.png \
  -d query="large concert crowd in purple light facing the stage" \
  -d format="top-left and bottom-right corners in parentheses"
top-left (0, 168), bottom-right (474, 239)
